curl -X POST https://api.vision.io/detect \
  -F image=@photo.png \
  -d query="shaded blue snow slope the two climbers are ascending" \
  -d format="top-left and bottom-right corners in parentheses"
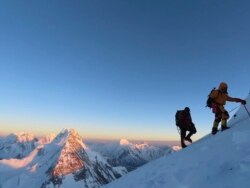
top-left (104, 96), bottom-right (250, 188)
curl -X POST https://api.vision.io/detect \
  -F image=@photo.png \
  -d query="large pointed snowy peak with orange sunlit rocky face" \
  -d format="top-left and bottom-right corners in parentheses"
top-left (0, 129), bottom-right (127, 188)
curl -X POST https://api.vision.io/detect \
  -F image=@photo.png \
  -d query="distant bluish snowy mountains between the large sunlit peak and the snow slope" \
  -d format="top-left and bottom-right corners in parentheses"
top-left (87, 139), bottom-right (173, 171)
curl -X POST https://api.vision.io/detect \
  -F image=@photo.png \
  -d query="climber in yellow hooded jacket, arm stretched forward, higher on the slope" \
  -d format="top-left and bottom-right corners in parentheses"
top-left (210, 82), bottom-right (246, 134)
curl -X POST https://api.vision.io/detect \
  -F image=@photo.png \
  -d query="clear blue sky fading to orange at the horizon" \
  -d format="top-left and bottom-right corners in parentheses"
top-left (0, 0), bottom-right (250, 140)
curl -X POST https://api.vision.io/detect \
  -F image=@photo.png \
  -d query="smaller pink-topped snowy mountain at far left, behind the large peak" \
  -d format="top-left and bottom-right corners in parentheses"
top-left (0, 132), bottom-right (37, 159)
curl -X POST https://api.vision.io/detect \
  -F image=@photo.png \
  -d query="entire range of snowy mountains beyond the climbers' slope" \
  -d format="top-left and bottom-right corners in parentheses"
top-left (0, 129), bottom-right (173, 188)
